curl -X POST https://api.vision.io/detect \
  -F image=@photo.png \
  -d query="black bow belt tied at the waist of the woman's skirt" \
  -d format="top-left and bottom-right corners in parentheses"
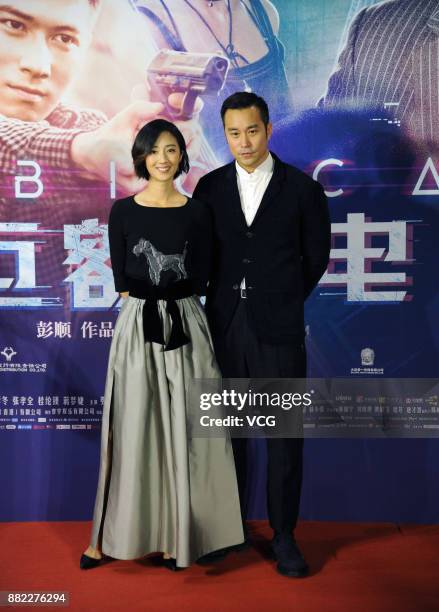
top-left (129, 278), bottom-right (194, 351)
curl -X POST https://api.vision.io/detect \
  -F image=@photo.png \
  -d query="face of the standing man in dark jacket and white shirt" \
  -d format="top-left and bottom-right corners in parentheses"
top-left (224, 106), bottom-right (272, 172)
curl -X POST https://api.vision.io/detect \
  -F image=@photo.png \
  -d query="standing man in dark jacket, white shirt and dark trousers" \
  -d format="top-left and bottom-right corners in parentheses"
top-left (194, 92), bottom-right (330, 576)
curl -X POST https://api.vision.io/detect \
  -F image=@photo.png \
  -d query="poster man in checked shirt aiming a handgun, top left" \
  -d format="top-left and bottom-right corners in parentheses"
top-left (0, 0), bottom-right (202, 200)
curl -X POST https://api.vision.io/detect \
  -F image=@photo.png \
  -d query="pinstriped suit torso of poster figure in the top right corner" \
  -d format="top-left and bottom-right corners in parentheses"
top-left (320, 0), bottom-right (439, 143)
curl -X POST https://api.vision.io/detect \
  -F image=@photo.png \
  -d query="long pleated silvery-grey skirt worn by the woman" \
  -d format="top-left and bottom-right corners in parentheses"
top-left (91, 297), bottom-right (244, 567)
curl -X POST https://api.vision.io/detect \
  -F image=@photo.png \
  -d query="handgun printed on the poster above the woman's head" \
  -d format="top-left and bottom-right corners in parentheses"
top-left (148, 49), bottom-right (229, 120)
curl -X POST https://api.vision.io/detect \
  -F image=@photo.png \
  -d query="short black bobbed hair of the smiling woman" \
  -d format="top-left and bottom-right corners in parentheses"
top-left (131, 119), bottom-right (190, 180)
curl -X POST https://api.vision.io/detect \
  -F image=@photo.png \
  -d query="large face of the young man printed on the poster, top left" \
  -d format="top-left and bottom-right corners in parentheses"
top-left (0, 0), bottom-right (97, 121)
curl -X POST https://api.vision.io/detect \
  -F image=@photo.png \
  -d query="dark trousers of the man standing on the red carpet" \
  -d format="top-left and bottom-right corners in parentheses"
top-left (214, 299), bottom-right (306, 533)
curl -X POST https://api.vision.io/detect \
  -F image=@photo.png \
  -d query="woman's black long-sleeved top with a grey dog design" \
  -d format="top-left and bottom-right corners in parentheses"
top-left (108, 196), bottom-right (212, 295)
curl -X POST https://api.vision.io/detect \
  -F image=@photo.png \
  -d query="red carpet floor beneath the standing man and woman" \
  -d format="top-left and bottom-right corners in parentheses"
top-left (0, 521), bottom-right (439, 612)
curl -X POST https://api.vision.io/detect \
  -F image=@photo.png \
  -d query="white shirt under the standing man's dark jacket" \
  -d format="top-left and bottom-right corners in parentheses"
top-left (235, 153), bottom-right (274, 289)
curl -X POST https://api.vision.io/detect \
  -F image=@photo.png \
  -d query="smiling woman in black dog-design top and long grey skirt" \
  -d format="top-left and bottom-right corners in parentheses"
top-left (80, 119), bottom-right (244, 569)
